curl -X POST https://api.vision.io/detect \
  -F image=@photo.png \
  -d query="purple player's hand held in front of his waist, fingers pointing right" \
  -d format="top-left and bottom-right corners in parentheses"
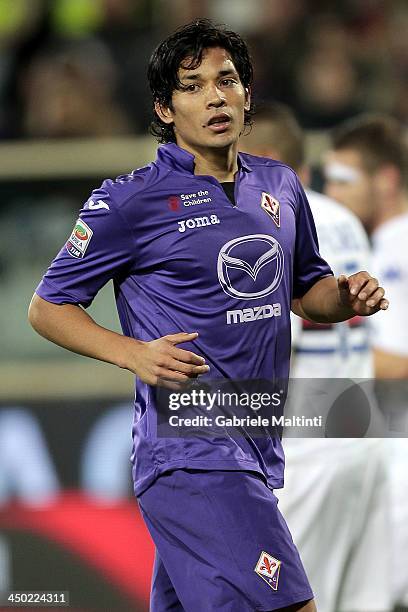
top-left (126, 332), bottom-right (210, 389)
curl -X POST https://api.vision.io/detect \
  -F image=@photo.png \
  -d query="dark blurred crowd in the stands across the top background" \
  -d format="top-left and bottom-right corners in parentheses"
top-left (0, 0), bottom-right (408, 140)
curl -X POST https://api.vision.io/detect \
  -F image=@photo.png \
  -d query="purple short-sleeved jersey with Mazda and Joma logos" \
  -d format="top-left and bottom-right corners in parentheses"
top-left (37, 144), bottom-right (332, 495)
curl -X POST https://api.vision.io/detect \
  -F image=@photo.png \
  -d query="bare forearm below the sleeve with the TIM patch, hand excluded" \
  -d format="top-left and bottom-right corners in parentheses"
top-left (29, 295), bottom-right (137, 368)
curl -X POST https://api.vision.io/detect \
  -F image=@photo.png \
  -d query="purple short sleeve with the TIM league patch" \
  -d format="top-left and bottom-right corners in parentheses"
top-left (36, 189), bottom-right (135, 307)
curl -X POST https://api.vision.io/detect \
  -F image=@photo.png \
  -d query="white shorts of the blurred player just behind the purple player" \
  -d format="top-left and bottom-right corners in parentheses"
top-left (275, 438), bottom-right (392, 612)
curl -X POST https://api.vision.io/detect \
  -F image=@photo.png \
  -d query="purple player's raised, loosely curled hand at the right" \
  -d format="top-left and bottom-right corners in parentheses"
top-left (337, 272), bottom-right (389, 317)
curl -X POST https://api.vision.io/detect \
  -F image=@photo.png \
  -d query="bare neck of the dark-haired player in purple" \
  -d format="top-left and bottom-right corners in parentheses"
top-left (177, 143), bottom-right (238, 183)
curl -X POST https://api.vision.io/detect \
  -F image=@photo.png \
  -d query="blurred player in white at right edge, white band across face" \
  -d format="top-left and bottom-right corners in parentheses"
top-left (325, 115), bottom-right (408, 606)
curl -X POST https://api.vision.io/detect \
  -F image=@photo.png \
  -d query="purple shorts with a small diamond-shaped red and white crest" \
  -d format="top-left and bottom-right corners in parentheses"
top-left (138, 470), bottom-right (313, 612)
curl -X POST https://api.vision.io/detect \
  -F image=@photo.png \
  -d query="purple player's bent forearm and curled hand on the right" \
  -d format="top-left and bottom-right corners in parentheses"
top-left (292, 272), bottom-right (388, 323)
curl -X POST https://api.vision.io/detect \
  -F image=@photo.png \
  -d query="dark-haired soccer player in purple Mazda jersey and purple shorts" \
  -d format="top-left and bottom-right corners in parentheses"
top-left (29, 20), bottom-right (388, 612)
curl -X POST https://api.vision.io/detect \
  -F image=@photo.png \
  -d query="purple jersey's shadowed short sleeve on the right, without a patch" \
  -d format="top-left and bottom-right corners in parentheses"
top-left (292, 179), bottom-right (333, 299)
